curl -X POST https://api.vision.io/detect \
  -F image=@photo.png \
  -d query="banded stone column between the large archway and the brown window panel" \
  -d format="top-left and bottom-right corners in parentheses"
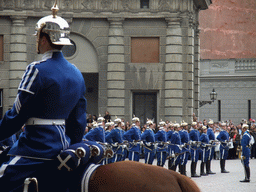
top-left (107, 18), bottom-right (125, 118)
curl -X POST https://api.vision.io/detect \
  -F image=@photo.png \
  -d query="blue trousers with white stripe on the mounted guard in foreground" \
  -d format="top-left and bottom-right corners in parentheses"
top-left (0, 156), bottom-right (68, 192)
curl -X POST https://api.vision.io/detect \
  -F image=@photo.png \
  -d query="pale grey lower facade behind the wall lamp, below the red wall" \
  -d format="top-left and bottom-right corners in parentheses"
top-left (199, 59), bottom-right (256, 124)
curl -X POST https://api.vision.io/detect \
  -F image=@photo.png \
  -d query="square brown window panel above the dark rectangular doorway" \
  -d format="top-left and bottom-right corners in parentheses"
top-left (131, 37), bottom-right (159, 63)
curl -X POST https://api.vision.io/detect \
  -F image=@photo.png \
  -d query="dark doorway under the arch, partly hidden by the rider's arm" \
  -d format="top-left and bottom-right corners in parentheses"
top-left (83, 73), bottom-right (99, 117)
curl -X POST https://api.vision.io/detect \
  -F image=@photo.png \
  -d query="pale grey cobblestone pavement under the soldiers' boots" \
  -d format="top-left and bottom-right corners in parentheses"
top-left (140, 159), bottom-right (256, 192)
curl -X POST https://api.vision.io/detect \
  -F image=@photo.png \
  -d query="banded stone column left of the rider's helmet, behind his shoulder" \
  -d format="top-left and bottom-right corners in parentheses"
top-left (9, 16), bottom-right (27, 107)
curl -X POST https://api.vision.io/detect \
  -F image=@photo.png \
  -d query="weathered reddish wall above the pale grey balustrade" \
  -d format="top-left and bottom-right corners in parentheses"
top-left (199, 0), bottom-right (256, 59)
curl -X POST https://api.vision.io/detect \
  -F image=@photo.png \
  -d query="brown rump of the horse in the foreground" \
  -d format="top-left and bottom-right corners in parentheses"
top-left (89, 161), bottom-right (200, 192)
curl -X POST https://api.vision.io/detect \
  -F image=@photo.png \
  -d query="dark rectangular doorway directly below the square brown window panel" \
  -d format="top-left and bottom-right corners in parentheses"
top-left (133, 92), bottom-right (157, 126)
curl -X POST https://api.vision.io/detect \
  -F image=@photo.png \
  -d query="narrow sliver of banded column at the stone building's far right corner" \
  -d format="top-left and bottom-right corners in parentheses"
top-left (194, 11), bottom-right (200, 117)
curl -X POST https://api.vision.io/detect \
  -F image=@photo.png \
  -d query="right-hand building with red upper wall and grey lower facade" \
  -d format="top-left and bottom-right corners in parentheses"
top-left (199, 0), bottom-right (256, 124)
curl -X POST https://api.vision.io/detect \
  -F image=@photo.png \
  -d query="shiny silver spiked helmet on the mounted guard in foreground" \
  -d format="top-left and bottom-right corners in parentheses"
top-left (35, 2), bottom-right (72, 49)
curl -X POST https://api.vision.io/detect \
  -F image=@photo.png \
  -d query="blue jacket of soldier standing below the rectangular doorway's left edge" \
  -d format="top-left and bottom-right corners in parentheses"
top-left (123, 126), bottom-right (141, 153)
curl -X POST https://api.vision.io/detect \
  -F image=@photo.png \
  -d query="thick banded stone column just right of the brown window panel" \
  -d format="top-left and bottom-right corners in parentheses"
top-left (164, 14), bottom-right (183, 122)
